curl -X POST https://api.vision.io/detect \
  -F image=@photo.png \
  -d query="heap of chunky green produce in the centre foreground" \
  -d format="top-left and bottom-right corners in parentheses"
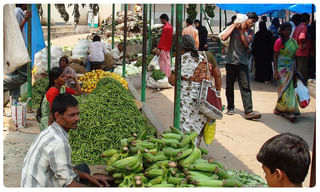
top-left (101, 128), bottom-right (265, 187)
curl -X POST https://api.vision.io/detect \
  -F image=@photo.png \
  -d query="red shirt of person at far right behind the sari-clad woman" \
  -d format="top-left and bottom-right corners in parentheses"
top-left (292, 23), bottom-right (310, 56)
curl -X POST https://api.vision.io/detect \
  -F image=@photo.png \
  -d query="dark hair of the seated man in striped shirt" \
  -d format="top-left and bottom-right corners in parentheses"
top-left (51, 93), bottom-right (78, 120)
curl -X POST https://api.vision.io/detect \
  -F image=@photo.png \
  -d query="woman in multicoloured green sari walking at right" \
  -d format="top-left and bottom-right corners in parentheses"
top-left (273, 23), bottom-right (300, 122)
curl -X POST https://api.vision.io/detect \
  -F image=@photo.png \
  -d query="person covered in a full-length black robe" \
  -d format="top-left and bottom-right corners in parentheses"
top-left (252, 21), bottom-right (273, 83)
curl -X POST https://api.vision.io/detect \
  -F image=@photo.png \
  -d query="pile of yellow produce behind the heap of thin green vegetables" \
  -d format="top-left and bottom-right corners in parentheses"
top-left (79, 69), bottom-right (128, 93)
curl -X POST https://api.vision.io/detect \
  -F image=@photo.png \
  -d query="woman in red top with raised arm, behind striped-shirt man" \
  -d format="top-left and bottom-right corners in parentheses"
top-left (36, 67), bottom-right (82, 131)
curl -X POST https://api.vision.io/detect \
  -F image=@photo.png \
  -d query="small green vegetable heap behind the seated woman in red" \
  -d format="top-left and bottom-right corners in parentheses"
top-left (20, 77), bottom-right (49, 109)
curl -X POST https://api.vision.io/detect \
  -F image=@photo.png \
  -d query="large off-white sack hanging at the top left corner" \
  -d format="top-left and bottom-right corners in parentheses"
top-left (3, 4), bottom-right (31, 74)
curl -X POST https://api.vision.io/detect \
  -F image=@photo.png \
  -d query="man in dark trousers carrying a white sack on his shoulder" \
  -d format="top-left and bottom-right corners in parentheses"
top-left (221, 12), bottom-right (261, 120)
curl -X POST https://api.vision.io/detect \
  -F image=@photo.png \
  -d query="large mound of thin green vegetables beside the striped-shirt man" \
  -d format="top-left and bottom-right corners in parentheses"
top-left (69, 78), bottom-right (156, 165)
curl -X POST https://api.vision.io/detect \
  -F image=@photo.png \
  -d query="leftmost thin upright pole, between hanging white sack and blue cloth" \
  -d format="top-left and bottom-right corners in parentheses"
top-left (27, 4), bottom-right (32, 110)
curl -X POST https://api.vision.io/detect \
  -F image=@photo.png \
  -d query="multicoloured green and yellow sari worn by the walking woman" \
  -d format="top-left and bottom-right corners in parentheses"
top-left (276, 38), bottom-right (300, 114)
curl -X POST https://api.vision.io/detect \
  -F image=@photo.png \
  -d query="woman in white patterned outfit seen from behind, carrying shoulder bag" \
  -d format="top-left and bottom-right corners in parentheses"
top-left (180, 35), bottom-right (222, 145)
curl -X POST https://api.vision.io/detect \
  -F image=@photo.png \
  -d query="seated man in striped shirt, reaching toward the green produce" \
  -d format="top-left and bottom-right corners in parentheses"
top-left (21, 94), bottom-right (108, 187)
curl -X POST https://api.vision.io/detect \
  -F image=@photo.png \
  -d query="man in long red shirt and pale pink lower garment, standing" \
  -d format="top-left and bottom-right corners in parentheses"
top-left (157, 14), bottom-right (173, 78)
